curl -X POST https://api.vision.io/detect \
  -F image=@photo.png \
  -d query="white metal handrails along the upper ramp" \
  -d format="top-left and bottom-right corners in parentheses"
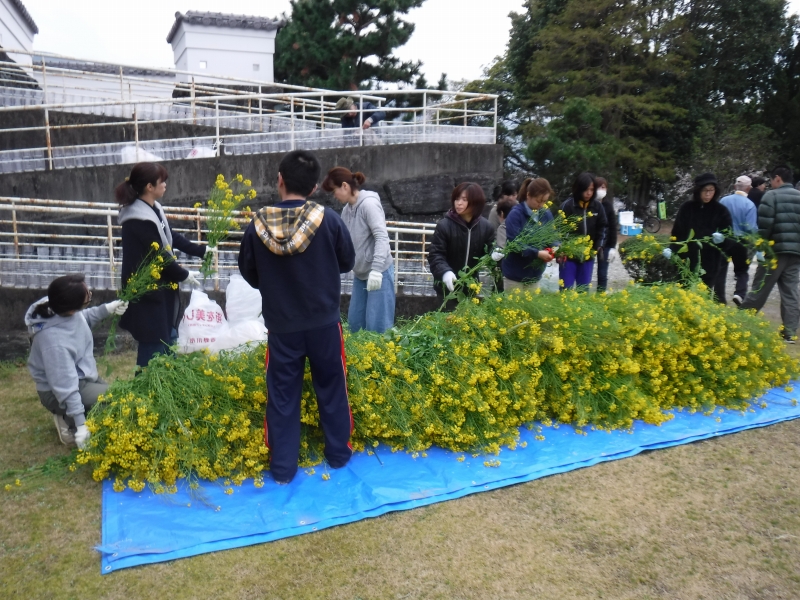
top-left (0, 49), bottom-right (498, 170)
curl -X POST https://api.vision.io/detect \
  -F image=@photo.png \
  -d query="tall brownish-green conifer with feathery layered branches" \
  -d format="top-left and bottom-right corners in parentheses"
top-left (523, 0), bottom-right (688, 201)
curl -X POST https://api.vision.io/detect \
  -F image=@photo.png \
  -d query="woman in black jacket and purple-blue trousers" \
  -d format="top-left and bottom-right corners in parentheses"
top-left (558, 173), bottom-right (608, 289)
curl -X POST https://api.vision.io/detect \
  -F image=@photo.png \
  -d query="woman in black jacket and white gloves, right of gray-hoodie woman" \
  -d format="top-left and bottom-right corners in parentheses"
top-left (428, 183), bottom-right (494, 308)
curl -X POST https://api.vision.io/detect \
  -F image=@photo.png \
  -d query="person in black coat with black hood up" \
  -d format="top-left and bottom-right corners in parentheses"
top-left (666, 173), bottom-right (733, 290)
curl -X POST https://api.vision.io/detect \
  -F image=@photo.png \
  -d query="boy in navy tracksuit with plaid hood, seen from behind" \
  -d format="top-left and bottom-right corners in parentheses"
top-left (239, 150), bottom-right (355, 483)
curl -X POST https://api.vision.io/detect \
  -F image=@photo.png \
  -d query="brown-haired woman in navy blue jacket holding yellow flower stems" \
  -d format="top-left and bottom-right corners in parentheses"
top-left (501, 178), bottom-right (553, 291)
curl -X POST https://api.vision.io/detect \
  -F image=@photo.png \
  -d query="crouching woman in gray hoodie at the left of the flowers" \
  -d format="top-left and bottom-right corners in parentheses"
top-left (25, 273), bottom-right (128, 448)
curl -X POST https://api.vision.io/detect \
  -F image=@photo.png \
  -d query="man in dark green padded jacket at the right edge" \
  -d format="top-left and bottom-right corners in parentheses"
top-left (739, 166), bottom-right (800, 344)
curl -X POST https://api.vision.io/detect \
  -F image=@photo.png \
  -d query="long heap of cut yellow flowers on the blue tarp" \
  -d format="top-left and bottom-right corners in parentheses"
top-left (78, 284), bottom-right (798, 492)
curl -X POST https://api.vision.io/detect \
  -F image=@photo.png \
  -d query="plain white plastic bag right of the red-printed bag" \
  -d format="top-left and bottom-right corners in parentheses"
top-left (216, 274), bottom-right (267, 351)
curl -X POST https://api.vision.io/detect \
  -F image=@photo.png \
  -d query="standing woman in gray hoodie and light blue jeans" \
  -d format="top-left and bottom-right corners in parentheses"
top-left (322, 167), bottom-right (395, 333)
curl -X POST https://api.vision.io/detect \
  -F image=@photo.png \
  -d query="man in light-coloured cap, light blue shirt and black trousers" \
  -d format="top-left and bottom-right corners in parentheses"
top-left (714, 175), bottom-right (758, 306)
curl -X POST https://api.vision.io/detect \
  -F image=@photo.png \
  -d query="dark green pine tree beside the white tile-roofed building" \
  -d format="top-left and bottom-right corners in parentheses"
top-left (275, 0), bottom-right (424, 90)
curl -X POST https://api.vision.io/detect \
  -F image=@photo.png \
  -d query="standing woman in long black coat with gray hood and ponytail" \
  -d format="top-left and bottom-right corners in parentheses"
top-left (114, 162), bottom-right (215, 367)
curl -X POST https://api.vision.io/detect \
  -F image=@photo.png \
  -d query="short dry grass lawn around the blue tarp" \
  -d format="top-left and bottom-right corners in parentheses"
top-left (0, 338), bottom-right (800, 600)
